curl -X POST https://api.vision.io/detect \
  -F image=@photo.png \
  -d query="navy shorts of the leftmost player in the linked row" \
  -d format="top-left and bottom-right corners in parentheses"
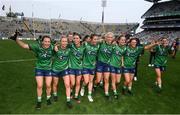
top-left (35, 69), bottom-right (52, 77)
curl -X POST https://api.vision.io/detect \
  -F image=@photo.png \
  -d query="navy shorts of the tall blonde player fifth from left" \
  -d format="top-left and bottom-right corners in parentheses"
top-left (96, 61), bottom-right (110, 73)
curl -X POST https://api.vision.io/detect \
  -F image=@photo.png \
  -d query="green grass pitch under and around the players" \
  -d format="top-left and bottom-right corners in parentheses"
top-left (0, 40), bottom-right (180, 114)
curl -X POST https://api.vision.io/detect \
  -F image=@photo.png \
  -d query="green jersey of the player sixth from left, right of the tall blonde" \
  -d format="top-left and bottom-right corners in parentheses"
top-left (110, 45), bottom-right (126, 68)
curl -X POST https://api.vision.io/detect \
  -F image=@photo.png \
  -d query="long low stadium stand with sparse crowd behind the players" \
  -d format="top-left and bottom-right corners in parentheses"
top-left (0, 16), bottom-right (139, 39)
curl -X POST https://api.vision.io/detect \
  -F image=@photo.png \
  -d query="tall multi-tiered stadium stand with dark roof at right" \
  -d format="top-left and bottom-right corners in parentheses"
top-left (135, 0), bottom-right (180, 42)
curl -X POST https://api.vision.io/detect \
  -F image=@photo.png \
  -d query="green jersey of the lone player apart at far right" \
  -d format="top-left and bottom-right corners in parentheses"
top-left (154, 45), bottom-right (171, 66)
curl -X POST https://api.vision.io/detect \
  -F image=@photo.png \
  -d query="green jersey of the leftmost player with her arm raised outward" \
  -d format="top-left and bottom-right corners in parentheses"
top-left (28, 43), bottom-right (53, 70)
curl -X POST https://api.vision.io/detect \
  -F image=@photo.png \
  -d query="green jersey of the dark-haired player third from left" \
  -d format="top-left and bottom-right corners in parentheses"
top-left (69, 44), bottom-right (84, 69)
